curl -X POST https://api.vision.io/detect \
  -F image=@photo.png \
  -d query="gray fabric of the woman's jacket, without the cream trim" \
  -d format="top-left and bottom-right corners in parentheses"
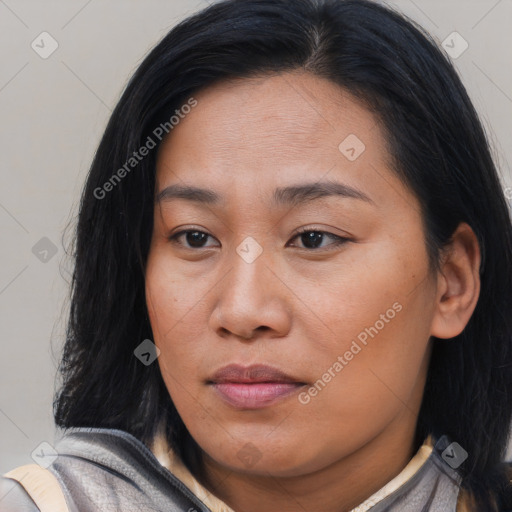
top-left (0, 428), bottom-right (476, 512)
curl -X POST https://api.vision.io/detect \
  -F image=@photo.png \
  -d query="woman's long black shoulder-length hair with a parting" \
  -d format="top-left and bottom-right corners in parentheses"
top-left (54, 0), bottom-right (512, 510)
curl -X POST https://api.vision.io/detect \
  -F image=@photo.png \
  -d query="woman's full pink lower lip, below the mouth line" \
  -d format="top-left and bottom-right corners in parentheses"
top-left (213, 382), bottom-right (305, 409)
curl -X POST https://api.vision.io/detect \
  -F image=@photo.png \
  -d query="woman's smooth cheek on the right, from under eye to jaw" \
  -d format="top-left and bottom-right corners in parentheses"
top-left (305, 237), bottom-right (435, 416)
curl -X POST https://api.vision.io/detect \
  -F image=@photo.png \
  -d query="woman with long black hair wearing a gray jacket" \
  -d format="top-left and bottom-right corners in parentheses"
top-left (3, 0), bottom-right (512, 512)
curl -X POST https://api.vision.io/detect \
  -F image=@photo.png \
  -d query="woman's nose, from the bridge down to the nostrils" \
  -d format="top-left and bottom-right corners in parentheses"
top-left (210, 241), bottom-right (293, 340)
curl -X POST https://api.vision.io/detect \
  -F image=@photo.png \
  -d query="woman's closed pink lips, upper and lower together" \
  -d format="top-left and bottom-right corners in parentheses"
top-left (207, 364), bottom-right (306, 409)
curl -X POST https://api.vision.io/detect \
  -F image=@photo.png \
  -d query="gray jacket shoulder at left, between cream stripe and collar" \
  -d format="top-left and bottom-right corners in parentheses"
top-left (43, 428), bottom-right (210, 512)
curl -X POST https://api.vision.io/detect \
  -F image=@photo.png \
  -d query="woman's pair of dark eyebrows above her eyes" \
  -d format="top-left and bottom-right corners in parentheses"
top-left (155, 181), bottom-right (375, 207)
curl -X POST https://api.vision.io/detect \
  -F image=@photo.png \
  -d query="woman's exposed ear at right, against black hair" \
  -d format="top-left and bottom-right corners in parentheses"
top-left (430, 222), bottom-right (480, 338)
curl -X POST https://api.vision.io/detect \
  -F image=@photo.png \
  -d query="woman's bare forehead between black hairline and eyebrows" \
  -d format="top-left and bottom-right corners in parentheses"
top-left (157, 72), bottom-right (387, 202)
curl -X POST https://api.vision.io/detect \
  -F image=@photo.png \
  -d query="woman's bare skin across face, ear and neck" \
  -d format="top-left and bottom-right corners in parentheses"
top-left (146, 71), bottom-right (480, 512)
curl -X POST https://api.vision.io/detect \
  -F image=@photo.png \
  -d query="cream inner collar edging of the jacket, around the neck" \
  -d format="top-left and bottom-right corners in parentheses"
top-left (150, 433), bottom-right (450, 512)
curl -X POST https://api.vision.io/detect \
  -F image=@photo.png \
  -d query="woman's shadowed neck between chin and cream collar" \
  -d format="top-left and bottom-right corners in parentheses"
top-left (198, 409), bottom-right (419, 512)
